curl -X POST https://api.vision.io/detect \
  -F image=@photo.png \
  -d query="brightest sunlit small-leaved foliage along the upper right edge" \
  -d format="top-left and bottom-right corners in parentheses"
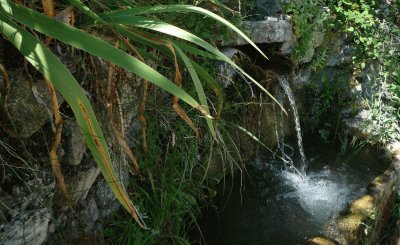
top-left (330, 0), bottom-right (400, 143)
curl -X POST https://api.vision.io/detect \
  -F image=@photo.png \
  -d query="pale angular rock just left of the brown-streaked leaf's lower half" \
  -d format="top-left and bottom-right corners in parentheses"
top-left (66, 165), bottom-right (100, 203)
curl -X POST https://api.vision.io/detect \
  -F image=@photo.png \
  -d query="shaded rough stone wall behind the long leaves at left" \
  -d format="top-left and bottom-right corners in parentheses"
top-left (0, 40), bottom-right (142, 245)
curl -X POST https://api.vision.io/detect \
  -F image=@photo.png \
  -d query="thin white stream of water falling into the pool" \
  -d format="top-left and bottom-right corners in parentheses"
top-left (278, 76), bottom-right (306, 176)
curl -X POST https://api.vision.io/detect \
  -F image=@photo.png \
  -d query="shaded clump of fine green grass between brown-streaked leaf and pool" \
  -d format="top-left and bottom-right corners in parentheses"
top-left (104, 96), bottom-right (241, 244)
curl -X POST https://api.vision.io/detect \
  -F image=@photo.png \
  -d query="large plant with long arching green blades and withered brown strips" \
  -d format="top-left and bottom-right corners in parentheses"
top-left (0, 0), bottom-right (276, 231)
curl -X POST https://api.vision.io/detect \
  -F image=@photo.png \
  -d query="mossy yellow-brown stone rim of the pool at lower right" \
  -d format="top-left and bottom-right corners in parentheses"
top-left (307, 154), bottom-right (400, 245)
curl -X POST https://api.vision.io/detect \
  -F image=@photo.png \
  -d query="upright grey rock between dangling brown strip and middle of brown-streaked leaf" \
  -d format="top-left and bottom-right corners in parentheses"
top-left (62, 119), bottom-right (87, 166)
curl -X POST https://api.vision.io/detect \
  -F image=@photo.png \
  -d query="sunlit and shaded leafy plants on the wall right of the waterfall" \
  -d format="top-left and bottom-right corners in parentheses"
top-left (285, 0), bottom-right (400, 143)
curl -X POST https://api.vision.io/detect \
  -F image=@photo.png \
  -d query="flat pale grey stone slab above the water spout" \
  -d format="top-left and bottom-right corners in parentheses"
top-left (222, 18), bottom-right (293, 46)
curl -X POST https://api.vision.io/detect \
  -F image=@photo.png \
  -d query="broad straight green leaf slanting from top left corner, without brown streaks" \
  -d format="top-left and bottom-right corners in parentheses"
top-left (0, 0), bottom-right (211, 117)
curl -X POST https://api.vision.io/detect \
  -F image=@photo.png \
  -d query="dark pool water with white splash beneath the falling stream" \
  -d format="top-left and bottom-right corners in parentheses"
top-left (195, 142), bottom-right (388, 245)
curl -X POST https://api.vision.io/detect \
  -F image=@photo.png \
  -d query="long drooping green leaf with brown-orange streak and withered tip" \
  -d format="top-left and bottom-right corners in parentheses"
top-left (0, 12), bottom-right (145, 227)
